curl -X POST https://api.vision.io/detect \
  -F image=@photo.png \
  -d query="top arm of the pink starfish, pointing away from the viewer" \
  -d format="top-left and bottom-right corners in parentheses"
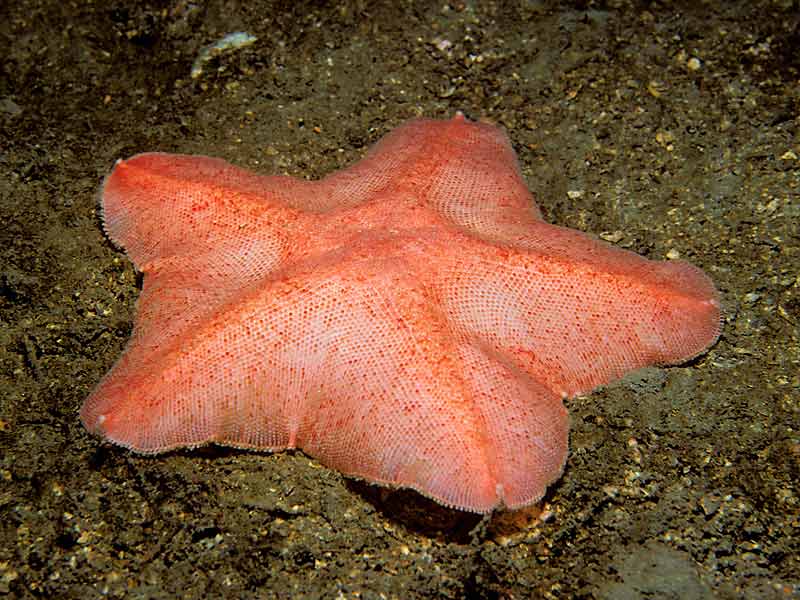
top-left (318, 115), bottom-right (540, 224)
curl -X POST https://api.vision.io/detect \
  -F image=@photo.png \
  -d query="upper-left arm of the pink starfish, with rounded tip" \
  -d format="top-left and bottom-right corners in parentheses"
top-left (101, 153), bottom-right (314, 274)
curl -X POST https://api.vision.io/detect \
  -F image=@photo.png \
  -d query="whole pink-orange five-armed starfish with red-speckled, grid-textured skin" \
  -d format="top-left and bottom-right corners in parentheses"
top-left (81, 114), bottom-right (720, 512)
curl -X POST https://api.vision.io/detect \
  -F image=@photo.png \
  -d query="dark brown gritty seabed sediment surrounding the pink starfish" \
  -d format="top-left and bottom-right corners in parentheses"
top-left (0, 0), bottom-right (800, 600)
